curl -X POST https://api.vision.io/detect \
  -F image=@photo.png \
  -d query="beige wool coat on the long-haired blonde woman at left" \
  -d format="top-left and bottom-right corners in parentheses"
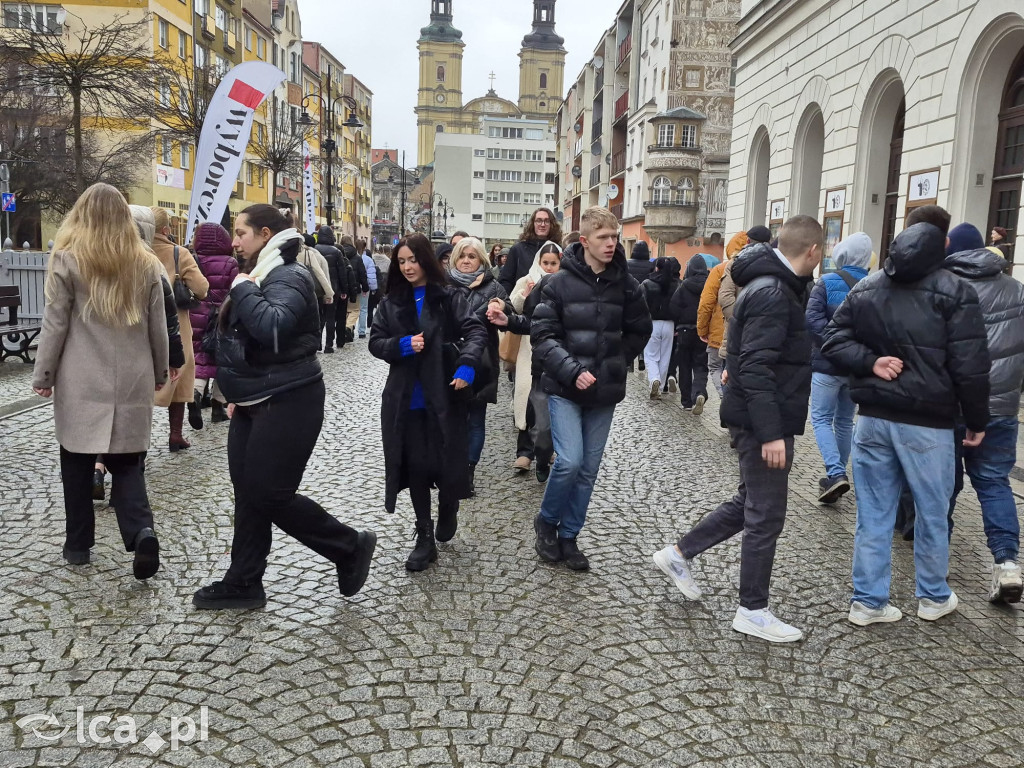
top-left (32, 253), bottom-right (169, 454)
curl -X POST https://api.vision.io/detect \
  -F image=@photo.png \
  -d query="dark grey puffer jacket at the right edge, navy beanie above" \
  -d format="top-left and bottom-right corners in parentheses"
top-left (945, 248), bottom-right (1024, 419)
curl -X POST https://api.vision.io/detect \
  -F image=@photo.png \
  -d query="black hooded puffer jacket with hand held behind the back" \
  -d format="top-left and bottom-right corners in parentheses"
top-left (821, 223), bottom-right (989, 432)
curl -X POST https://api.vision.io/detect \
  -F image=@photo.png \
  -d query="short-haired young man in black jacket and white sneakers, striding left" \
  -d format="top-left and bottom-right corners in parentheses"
top-left (654, 216), bottom-right (823, 643)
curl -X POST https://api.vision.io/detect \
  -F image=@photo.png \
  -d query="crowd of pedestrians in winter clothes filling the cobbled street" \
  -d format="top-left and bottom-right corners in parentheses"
top-left (33, 184), bottom-right (1024, 642)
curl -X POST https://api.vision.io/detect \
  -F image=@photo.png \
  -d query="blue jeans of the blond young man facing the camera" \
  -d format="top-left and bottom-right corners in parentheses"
top-left (541, 395), bottom-right (615, 539)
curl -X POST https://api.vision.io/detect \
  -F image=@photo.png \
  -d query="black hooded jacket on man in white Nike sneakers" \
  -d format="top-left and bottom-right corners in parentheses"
top-left (721, 243), bottom-right (811, 443)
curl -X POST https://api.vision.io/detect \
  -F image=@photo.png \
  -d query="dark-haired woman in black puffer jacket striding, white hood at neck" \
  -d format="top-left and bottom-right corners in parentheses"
top-left (193, 205), bottom-right (377, 609)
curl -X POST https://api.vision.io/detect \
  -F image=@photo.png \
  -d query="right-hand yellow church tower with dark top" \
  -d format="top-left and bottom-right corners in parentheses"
top-left (519, 0), bottom-right (565, 120)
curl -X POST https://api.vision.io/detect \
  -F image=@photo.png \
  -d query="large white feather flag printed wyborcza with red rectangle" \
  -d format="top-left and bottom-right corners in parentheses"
top-left (185, 61), bottom-right (286, 243)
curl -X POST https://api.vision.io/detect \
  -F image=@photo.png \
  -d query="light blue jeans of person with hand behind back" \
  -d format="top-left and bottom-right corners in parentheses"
top-left (853, 416), bottom-right (954, 608)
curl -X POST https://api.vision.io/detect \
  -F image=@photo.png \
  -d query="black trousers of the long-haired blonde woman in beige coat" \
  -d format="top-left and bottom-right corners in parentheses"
top-left (60, 445), bottom-right (153, 552)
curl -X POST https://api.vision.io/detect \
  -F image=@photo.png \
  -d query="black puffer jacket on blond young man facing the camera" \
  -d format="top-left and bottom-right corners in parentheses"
top-left (529, 243), bottom-right (651, 407)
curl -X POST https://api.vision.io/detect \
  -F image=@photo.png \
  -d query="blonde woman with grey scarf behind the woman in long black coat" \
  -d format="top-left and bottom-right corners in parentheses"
top-left (449, 238), bottom-right (512, 496)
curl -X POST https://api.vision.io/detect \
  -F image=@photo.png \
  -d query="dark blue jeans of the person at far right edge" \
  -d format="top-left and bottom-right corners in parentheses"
top-left (949, 417), bottom-right (1021, 562)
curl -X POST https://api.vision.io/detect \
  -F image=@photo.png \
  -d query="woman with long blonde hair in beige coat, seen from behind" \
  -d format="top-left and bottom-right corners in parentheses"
top-left (32, 183), bottom-right (170, 579)
